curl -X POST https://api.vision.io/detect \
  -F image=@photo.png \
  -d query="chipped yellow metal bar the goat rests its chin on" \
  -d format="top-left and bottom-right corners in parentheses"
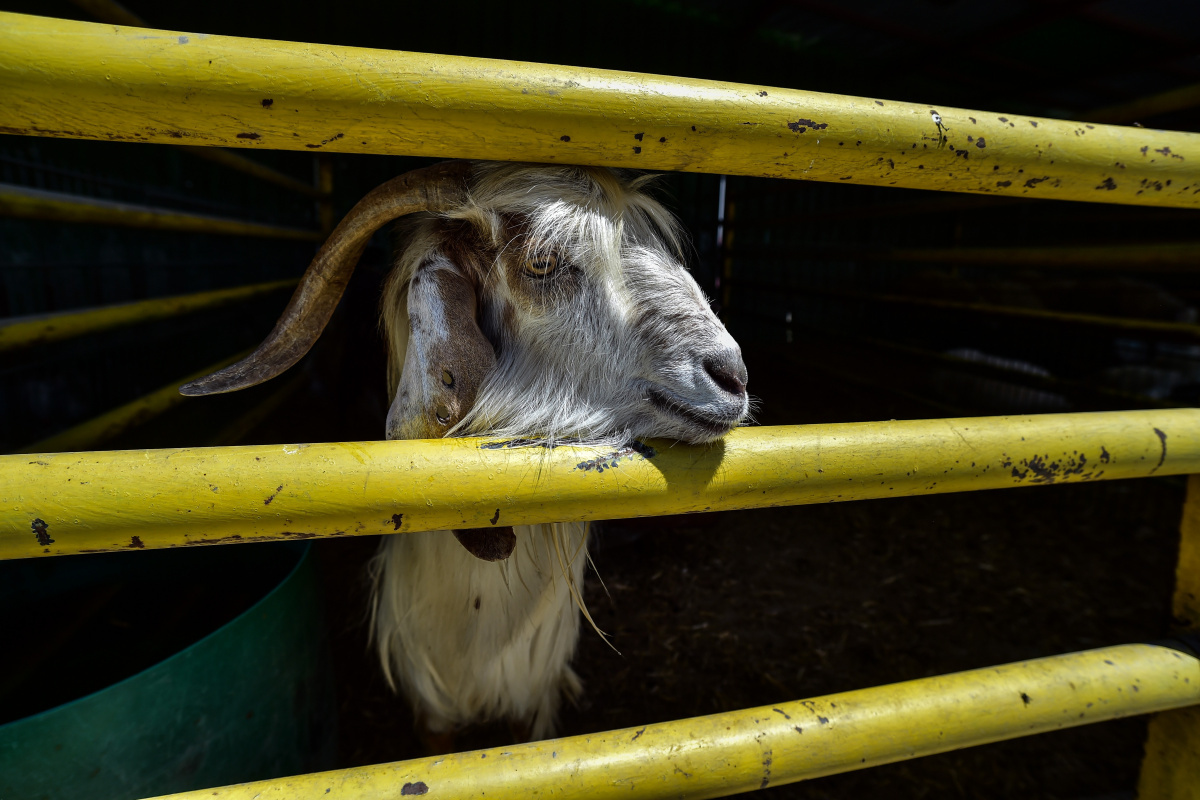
top-left (0, 409), bottom-right (1200, 558)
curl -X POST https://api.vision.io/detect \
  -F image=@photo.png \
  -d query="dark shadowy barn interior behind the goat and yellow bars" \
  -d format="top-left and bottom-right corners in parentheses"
top-left (0, 0), bottom-right (1200, 799)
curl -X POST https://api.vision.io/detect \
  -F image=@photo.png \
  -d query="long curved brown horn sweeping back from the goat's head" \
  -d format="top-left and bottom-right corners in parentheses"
top-left (179, 161), bottom-right (470, 397)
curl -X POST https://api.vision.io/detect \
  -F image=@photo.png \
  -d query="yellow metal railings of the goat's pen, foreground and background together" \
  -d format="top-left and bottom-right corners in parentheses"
top-left (0, 6), bottom-right (1200, 798)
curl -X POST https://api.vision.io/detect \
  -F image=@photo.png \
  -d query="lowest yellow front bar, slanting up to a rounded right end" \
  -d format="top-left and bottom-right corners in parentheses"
top-left (150, 644), bottom-right (1200, 800)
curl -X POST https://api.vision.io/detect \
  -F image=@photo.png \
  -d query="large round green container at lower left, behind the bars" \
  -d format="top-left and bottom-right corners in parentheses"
top-left (0, 543), bottom-right (336, 800)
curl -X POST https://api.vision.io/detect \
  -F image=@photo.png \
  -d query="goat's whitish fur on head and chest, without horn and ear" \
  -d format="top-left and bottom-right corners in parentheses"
top-left (372, 164), bottom-right (749, 739)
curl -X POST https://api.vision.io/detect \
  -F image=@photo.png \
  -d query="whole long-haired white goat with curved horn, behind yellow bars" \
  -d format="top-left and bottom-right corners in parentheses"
top-left (182, 162), bottom-right (749, 742)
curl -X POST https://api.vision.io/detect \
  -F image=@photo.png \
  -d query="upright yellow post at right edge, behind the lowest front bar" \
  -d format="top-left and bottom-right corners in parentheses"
top-left (1138, 475), bottom-right (1200, 800)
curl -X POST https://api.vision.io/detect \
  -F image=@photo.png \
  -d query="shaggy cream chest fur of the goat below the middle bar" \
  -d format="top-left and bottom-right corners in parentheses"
top-left (373, 523), bottom-right (587, 740)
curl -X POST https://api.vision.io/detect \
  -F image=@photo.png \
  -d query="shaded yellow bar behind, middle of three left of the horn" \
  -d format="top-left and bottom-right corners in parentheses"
top-left (0, 278), bottom-right (296, 353)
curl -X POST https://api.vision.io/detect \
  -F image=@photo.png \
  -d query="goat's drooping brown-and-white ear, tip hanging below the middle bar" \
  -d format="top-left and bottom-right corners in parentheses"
top-left (388, 257), bottom-right (516, 561)
